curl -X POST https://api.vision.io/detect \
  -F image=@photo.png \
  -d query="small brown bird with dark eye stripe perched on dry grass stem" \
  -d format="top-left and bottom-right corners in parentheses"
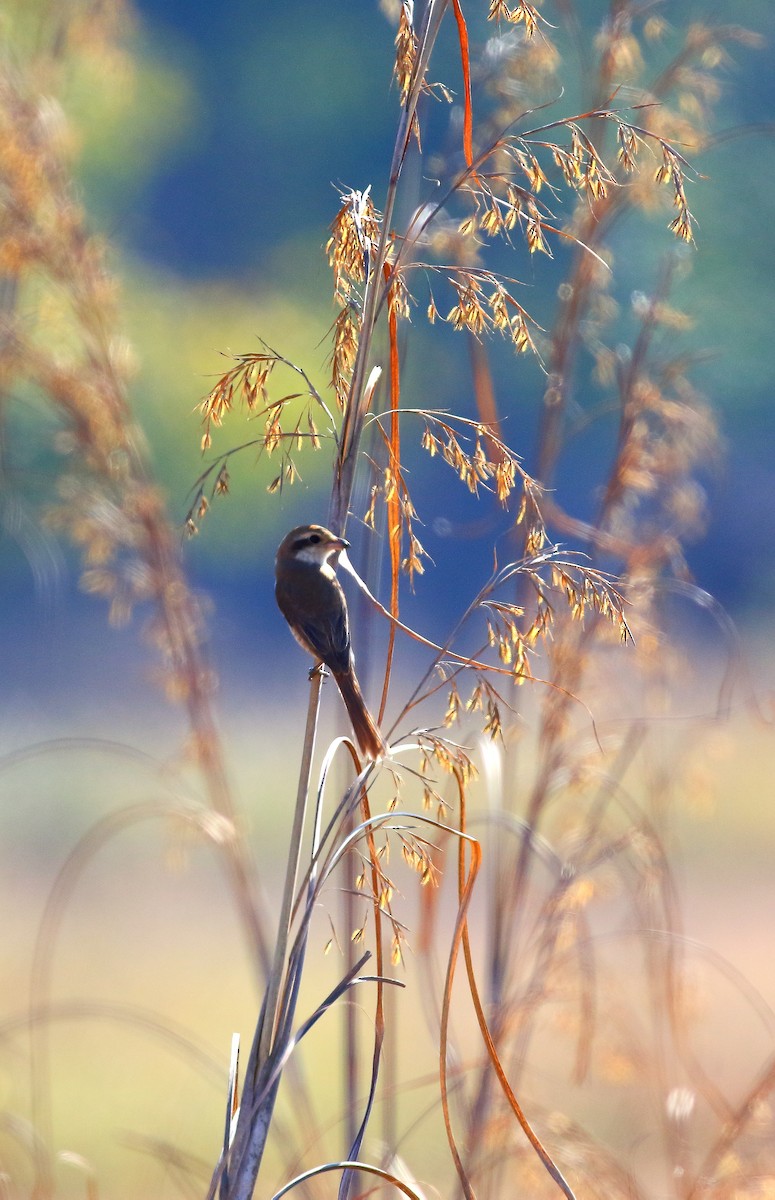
top-left (275, 524), bottom-right (388, 761)
